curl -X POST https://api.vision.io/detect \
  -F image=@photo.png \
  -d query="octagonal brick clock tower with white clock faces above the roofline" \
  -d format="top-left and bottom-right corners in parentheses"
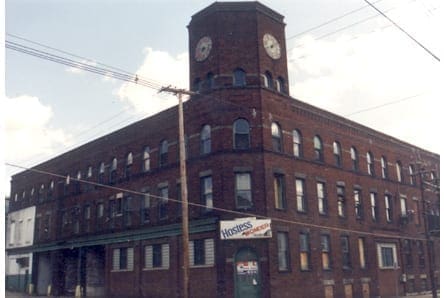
top-left (188, 2), bottom-right (288, 94)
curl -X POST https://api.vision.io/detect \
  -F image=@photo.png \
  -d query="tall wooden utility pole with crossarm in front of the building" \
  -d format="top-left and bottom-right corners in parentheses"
top-left (159, 87), bottom-right (195, 298)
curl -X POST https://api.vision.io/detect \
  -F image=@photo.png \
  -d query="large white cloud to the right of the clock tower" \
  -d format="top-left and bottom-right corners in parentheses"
top-left (288, 12), bottom-right (441, 152)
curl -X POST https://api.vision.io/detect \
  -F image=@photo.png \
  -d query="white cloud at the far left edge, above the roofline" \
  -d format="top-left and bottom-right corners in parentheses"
top-left (3, 95), bottom-right (71, 165)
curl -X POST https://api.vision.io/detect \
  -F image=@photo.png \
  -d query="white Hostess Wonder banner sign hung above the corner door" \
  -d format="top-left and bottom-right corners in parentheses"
top-left (220, 217), bottom-right (271, 240)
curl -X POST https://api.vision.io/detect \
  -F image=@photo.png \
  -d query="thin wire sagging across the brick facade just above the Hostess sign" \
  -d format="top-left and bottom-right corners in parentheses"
top-left (5, 162), bottom-right (425, 240)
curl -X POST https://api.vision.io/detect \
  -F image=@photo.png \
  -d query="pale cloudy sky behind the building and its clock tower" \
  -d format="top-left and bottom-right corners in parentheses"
top-left (0, 0), bottom-right (443, 197)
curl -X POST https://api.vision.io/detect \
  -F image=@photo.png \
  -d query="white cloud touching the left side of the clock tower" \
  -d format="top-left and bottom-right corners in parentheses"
top-left (117, 48), bottom-right (188, 116)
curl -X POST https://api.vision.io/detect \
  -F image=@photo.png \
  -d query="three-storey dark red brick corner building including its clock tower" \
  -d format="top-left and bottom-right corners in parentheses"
top-left (8, 2), bottom-right (439, 297)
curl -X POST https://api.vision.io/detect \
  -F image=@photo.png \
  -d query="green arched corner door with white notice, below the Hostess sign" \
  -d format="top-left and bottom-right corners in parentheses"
top-left (234, 247), bottom-right (262, 298)
